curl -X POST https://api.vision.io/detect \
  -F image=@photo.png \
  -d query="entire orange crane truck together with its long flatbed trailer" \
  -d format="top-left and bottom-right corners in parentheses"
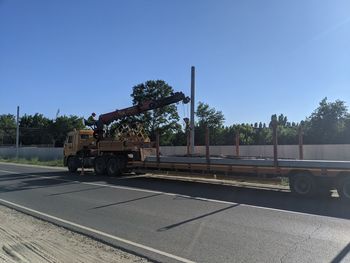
top-left (64, 92), bottom-right (350, 202)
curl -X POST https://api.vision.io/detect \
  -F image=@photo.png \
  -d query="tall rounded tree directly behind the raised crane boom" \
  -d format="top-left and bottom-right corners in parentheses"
top-left (131, 80), bottom-right (181, 144)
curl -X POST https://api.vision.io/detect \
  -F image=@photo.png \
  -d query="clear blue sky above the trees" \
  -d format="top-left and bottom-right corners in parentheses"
top-left (0, 0), bottom-right (350, 124)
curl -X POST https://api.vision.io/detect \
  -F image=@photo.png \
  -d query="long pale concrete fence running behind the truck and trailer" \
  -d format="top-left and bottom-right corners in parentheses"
top-left (0, 144), bottom-right (350, 161)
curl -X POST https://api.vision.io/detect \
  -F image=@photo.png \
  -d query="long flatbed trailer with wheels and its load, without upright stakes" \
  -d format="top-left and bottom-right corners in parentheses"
top-left (131, 156), bottom-right (350, 202)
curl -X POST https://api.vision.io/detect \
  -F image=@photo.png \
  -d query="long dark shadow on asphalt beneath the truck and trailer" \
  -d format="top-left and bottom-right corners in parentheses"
top-left (0, 171), bottom-right (350, 221)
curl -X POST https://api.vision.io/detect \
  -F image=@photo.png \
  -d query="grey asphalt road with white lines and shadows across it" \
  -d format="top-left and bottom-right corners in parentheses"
top-left (0, 163), bottom-right (350, 262)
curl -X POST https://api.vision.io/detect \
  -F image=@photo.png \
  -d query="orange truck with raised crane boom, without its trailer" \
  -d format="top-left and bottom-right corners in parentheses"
top-left (63, 92), bottom-right (190, 176)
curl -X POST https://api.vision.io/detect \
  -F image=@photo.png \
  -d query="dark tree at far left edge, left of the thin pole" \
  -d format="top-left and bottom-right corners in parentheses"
top-left (0, 114), bottom-right (16, 144)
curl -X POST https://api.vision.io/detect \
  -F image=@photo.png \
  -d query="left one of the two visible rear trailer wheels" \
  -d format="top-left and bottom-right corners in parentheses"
top-left (289, 174), bottom-right (316, 196)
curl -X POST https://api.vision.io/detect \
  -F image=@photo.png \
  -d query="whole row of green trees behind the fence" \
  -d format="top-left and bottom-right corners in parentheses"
top-left (0, 94), bottom-right (350, 146)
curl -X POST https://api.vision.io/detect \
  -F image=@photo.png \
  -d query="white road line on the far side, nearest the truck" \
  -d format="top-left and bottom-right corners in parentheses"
top-left (0, 170), bottom-right (345, 220)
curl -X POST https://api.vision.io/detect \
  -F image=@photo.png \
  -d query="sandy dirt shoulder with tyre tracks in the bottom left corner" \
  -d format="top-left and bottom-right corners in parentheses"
top-left (0, 205), bottom-right (149, 263)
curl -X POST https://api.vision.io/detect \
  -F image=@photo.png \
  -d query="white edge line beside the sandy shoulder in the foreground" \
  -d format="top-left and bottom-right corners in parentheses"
top-left (0, 199), bottom-right (194, 263)
